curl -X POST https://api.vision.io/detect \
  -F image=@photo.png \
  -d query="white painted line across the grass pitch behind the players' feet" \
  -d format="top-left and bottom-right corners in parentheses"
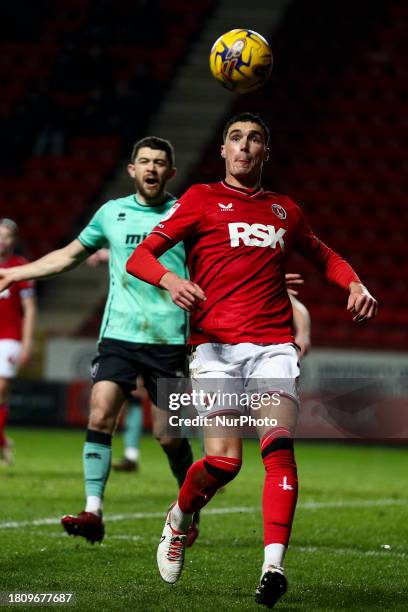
top-left (0, 498), bottom-right (408, 529)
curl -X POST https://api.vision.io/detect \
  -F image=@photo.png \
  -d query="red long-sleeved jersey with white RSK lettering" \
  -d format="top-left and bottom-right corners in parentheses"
top-left (130, 182), bottom-right (358, 344)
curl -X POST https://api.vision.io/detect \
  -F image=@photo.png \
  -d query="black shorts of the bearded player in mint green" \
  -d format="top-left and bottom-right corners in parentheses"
top-left (91, 338), bottom-right (187, 405)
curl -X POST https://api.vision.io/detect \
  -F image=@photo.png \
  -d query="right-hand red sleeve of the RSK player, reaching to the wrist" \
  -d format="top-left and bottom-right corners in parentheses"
top-left (294, 204), bottom-right (360, 290)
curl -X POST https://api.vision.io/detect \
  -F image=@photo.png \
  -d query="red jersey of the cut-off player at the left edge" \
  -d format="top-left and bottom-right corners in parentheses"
top-left (0, 255), bottom-right (34, 340)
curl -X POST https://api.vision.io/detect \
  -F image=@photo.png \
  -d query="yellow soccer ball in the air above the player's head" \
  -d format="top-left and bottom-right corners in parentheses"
top-left (210, 30), bottom-right (273, 93)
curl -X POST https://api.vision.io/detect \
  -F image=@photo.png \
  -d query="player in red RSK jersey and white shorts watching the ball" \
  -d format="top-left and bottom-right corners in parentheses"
top-left (127, 113), bottom-right (377, 607)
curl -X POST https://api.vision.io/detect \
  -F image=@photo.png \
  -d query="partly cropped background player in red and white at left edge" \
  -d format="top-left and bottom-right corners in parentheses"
top-left (0, 218), bottom-right (36, 464)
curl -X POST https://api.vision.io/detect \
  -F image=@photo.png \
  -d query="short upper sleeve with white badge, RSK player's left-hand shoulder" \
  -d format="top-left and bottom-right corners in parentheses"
top-left (152, 185), bottom-right (203, 244)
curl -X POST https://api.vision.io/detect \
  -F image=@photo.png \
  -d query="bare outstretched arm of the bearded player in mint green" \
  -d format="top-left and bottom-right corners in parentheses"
top-left (0, 240), bottom-right (89, 293)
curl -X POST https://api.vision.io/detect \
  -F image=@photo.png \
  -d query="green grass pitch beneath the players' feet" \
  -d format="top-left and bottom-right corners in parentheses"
top-left (0, 429), bottom-right (408, 612)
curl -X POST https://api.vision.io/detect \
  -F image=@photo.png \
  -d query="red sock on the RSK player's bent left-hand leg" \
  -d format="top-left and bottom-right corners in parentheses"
top-left (178, 455), bottom-right (242, 514)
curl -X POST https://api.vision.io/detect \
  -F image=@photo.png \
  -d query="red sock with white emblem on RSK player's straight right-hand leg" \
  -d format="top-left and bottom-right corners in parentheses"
top-left (261, 428), bottom-right (298, 546)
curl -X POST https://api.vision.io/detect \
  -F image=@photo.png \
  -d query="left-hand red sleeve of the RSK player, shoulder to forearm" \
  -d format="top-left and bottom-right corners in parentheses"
top-left (126, 186), bottom-right (202, 287)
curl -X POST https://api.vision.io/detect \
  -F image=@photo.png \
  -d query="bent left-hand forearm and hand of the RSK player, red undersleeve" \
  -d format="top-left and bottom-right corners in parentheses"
top-left (126, 234), bottom-right (206, 311)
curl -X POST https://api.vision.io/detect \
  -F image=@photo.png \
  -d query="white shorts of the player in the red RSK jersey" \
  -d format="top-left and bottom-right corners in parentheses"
top-left (190, 342), bottom-right (300, 417)
